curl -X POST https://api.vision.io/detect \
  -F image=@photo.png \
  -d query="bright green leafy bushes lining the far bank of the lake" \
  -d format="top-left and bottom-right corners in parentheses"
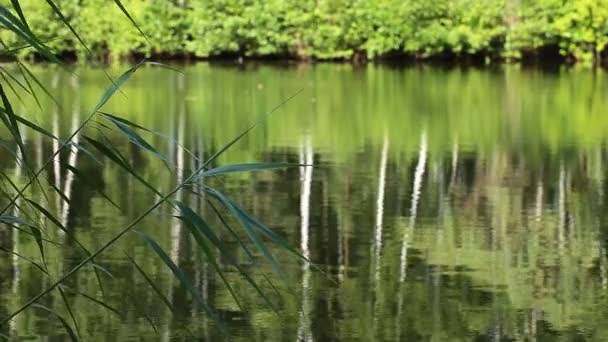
top-left (0, 0), bottom-right (608, 66)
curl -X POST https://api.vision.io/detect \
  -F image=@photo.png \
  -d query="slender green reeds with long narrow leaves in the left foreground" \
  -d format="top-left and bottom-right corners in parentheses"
top-left (0, 0), bottom-right (306, 340)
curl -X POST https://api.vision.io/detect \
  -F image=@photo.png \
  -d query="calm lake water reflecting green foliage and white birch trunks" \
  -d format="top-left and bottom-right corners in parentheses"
top-left (0, 64), bottom-right (608, 341)
